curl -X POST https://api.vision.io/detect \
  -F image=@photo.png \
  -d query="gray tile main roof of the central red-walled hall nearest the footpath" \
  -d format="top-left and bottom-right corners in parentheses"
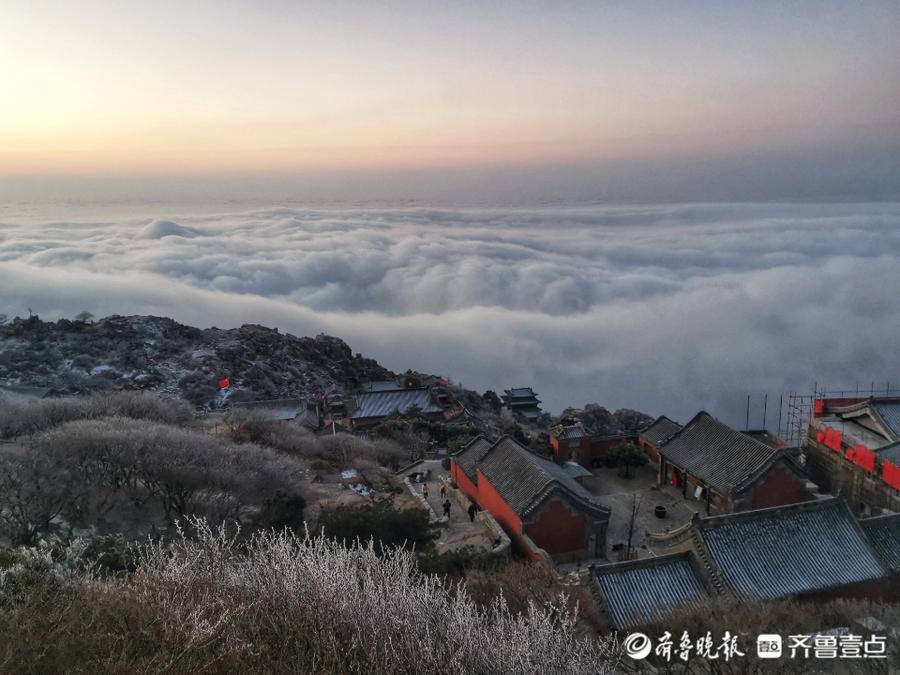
top-left (478, 436), bottom-right (609, 518)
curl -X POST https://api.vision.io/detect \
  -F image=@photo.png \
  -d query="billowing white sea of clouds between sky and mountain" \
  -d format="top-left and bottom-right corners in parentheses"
top-left (0, 204), bottom-right (900, 428)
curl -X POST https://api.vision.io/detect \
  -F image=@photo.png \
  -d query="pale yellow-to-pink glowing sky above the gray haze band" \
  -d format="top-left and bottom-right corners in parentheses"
top-left (0, 0), bottom-right (900, 193)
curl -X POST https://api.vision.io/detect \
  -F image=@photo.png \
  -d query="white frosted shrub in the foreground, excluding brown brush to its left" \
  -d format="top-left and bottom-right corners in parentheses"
top-left (130, 520), bottom-right (617, 675)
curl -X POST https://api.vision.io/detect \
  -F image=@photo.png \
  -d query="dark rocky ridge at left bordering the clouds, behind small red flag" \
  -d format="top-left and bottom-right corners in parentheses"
top-left (0, 315), bottom-right (395, 408)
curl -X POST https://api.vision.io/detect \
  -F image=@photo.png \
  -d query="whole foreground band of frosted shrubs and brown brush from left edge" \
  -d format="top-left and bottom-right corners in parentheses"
top-left (0, 520), bottom-right (620, 675)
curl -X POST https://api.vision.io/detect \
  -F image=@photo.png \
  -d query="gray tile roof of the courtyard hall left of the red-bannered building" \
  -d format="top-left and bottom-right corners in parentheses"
top-left (658, 410), bottom-right (783, 492)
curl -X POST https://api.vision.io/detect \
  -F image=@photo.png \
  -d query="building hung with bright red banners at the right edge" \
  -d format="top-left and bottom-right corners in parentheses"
top-left (806, 397), bottom-right (900, 514)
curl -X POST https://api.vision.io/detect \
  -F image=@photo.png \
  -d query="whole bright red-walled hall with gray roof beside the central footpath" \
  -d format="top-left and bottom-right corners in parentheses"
top-left (450, 436), bottom-right (610, 561)
